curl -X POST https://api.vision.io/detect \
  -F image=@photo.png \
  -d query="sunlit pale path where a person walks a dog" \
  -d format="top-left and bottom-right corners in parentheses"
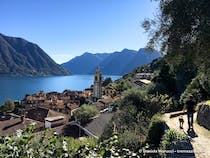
top-left (164, 113), bottom-right (210, 158)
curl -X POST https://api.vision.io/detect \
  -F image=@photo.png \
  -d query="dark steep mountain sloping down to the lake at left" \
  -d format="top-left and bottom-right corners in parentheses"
top-left (0, 34), bottom-right (70, 76)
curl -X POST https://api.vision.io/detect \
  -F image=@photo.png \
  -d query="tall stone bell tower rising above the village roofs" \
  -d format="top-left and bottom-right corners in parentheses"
top-left (93, 67), bottom-right (102, 100)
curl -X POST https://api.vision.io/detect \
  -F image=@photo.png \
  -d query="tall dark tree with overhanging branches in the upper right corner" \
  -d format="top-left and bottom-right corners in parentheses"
top-left (142, 0), bottom-right (210, 95)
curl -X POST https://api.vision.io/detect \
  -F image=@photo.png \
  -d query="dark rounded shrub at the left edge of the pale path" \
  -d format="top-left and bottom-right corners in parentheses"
top-left (147, 114), bottom-right (166, 147)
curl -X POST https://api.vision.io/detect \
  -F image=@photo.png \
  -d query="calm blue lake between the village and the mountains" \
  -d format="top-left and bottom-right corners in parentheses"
top-left (0, 75), bottom-right (121, 105)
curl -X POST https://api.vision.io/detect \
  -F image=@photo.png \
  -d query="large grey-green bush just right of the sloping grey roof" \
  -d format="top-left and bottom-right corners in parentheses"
top-left (101, 105), bottom-right (149, 145)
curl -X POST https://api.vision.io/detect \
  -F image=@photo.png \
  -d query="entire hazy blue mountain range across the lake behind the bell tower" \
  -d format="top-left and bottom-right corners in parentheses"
top-left (62, 49), bottom-right (161, 75)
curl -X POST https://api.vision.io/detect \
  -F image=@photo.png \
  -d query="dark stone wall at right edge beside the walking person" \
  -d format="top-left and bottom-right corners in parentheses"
top-left (197, 103), bottom-right (210, 130)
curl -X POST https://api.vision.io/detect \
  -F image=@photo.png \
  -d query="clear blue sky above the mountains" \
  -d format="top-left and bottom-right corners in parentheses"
top-left (0, 0), bottom-right (158, 64)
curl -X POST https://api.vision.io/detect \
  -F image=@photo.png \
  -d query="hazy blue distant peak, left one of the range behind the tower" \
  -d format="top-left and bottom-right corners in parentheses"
top-left (62, 52), bottom-right (109, 75)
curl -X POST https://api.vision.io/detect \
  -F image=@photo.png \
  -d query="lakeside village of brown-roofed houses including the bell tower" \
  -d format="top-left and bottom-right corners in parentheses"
top-left (0, 67), bottom-right (151, 138)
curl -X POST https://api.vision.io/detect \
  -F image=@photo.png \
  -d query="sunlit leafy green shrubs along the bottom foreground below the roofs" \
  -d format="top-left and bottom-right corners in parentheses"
top-left (0, 124), bottom-right (141, 158)
